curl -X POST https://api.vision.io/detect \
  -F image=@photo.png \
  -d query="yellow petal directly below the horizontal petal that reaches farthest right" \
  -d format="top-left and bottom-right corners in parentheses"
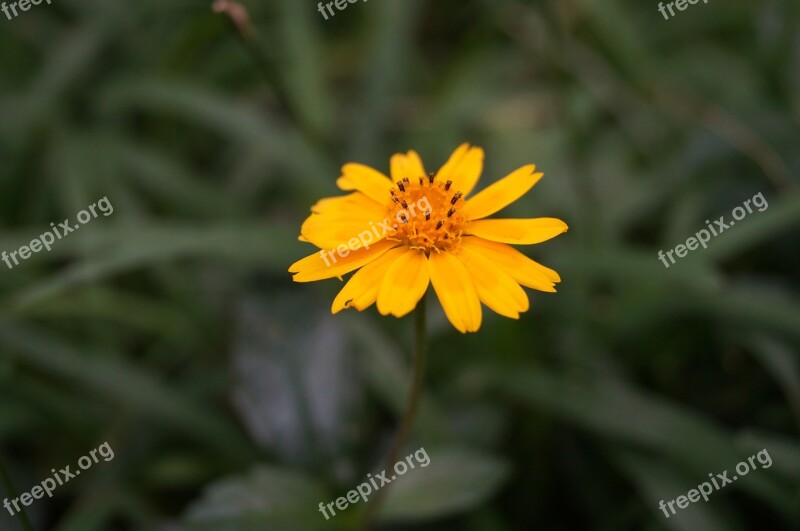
top-left (461, 236), bottom-right (561, 292)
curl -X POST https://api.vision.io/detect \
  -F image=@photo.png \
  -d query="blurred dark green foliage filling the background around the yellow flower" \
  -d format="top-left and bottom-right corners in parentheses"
top-left (0, 0), bottom-right (800, 531)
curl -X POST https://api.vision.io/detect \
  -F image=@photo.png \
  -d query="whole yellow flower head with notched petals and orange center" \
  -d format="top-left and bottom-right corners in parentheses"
top-left (289, 144), bottom-right (567, 332)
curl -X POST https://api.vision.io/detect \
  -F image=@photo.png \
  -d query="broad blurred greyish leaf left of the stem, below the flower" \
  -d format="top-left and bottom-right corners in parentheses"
top-left (232, 294), bottom-right (363, 468)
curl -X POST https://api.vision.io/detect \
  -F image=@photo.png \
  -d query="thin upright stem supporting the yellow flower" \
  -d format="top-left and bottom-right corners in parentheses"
top-left (360, 296), bottom-right (426, 531)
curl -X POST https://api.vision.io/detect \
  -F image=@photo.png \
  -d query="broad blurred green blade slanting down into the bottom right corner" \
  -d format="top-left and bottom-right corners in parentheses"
top-left (476, 368), bottom-right (800, 521)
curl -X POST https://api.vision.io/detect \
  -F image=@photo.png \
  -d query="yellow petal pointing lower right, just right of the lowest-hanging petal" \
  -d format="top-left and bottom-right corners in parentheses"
top-left (457, 247), bottom-right (529, 319)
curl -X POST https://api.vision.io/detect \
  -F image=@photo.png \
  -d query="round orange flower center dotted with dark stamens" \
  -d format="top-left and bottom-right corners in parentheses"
top-left (388, 173), bottom-right (467, 253)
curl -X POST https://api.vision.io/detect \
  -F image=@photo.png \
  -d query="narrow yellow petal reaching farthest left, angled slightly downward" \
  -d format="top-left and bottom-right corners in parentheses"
top-left (289, 240), bottom-right (398, 282)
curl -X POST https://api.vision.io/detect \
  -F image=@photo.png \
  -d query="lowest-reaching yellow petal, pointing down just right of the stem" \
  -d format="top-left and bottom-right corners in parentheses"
top-left (428, 252), bottom-right (482, 333)
